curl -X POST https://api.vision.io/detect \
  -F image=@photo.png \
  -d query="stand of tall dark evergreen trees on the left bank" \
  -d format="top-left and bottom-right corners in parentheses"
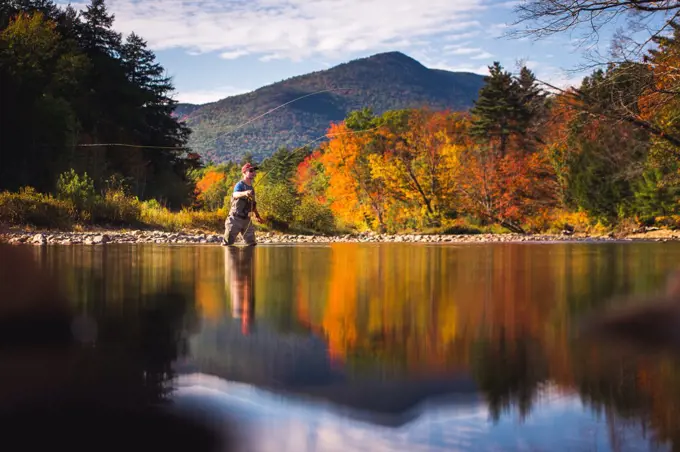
top-left (0, 0), bottom-right (200, 206)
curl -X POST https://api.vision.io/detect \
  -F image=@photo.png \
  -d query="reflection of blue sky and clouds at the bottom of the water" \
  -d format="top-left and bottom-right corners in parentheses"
top-left (175, 374), bottom-right (664, 452)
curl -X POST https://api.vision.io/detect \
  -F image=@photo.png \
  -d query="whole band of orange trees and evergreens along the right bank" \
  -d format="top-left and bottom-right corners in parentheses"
top-left (274, 36), bottom-right (680, 233)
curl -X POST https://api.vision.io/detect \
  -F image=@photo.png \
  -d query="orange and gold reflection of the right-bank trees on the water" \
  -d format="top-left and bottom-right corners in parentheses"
top-left (295, 244), bottom-right (680, 446)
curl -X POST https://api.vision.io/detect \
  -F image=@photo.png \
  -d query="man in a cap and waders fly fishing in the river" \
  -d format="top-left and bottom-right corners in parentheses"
top-left (224, 163), bottom-right (262, 245)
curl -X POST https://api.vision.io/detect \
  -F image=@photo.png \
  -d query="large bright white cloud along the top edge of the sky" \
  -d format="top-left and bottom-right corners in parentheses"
top-left (62, 0), bottom-right (487, 61)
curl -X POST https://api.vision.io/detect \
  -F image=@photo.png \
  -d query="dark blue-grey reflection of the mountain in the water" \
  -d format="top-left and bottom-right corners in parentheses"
top-left (175, 314), bottom-right (477, 425)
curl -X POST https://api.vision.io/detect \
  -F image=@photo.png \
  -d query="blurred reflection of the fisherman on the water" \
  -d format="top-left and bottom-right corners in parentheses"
top-left (225, 247), bottom-right (255, 334)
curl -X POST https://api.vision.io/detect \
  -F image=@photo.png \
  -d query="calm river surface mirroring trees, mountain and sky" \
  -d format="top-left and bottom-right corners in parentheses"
top-left (33, 243), bottom-right (680, 451)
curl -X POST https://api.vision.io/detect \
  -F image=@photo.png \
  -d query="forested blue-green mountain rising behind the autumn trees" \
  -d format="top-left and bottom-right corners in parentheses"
top-left (175, 52), bottom-right (484, 163)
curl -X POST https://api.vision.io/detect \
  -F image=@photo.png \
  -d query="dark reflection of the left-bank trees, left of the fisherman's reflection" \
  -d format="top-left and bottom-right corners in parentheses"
top-left (35, 247), bottom-right (199, 404)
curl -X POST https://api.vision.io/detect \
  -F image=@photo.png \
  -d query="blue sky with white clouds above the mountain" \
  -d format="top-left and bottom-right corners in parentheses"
top-left (61, 0), bottom-right (636, 103)
